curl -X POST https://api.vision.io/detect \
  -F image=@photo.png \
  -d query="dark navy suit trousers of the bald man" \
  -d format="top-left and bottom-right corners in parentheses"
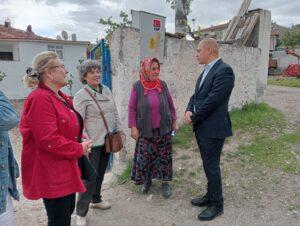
top-left (196, 133), bottom-right (225, 206)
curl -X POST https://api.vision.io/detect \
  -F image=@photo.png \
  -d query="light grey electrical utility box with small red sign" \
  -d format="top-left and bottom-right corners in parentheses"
top-left (131, 10), bottom-right (166, 63)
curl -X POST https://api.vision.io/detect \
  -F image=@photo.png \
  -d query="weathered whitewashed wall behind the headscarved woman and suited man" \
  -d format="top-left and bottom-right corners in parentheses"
top-left (110, 28), bottom-right (267, 153)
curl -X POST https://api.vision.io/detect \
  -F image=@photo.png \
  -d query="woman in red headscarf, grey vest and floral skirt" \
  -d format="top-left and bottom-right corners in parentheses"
top-left (128, 58), bottom-right (178, 198)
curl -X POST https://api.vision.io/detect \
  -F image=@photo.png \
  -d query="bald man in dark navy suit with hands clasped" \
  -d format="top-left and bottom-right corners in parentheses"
top-left (184, 38), bottom-right (234, 221)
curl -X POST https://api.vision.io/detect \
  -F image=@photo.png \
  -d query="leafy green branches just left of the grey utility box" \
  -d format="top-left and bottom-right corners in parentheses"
top-left (99, 11), bottom-right (132, 41)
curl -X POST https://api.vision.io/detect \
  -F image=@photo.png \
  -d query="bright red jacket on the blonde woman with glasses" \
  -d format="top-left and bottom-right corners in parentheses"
top-left (19, 84), bottom-right (85, 199)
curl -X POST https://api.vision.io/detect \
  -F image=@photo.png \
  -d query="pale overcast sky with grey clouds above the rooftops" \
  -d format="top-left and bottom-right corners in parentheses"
top-left (0, 0), bottom-right (300, 42)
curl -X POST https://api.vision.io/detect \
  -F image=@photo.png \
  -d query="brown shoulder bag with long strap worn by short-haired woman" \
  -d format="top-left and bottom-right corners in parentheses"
top-left (84, 87), bottom-right (123, 153)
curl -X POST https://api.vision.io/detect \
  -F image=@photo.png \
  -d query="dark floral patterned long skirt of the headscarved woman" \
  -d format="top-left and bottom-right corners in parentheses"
top-left (131, 129), bottom-right (173, 184)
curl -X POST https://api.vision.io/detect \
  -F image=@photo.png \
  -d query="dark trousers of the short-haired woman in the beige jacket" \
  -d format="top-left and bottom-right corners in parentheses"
top-left (76, 147), bottom-right (110, 217)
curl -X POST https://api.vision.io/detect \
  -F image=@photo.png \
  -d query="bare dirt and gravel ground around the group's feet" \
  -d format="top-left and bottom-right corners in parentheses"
top-left (11, 86), bottom-right (300, 226)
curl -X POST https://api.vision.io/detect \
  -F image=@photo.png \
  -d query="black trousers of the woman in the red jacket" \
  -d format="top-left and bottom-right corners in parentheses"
top-left (43, 193), bottom-right (75, 226)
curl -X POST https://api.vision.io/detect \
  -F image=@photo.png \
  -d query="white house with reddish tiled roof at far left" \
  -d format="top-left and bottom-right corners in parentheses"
top-left (0, 20), bottom-right (90, 99)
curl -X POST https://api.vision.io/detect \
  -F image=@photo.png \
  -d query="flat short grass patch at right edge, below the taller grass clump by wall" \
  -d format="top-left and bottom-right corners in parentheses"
top-left (238, 130), bottom-right (300, 174)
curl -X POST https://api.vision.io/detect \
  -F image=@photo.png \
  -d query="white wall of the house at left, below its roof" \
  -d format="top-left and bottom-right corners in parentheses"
top-left (0, 42), bottom-right (86, 99)
